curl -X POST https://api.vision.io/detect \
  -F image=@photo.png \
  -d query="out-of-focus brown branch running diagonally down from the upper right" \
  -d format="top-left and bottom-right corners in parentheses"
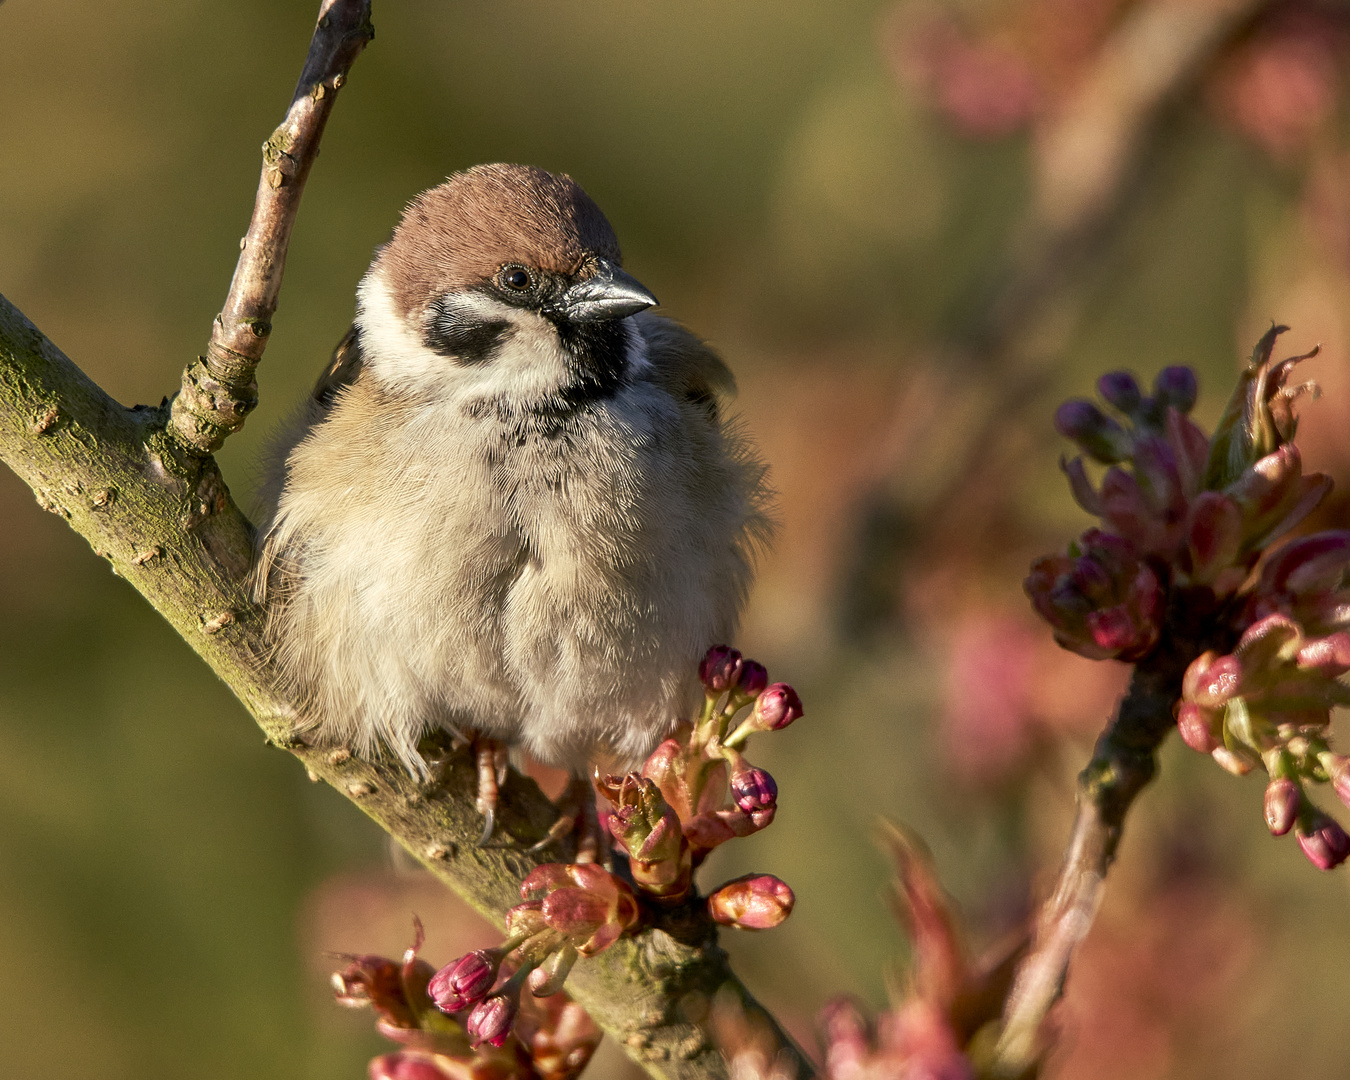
top-left (841, 0), bottom-right (1270, 635)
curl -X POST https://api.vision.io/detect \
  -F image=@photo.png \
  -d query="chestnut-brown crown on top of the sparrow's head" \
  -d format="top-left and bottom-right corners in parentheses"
top-left (375, 165), bottom-right (621, 317)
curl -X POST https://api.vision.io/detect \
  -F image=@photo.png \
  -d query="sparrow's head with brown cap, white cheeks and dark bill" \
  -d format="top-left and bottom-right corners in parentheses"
top-left (358, 165), bottom-right (657, 410)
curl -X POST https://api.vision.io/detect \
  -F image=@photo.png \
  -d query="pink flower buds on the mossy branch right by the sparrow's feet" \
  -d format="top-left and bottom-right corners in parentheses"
top-left (428, 645), bottom-right (802, 1046)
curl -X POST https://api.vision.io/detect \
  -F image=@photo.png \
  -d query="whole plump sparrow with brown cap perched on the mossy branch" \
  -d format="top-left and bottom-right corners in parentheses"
top-left (252, 165), bottom-right (770, 836)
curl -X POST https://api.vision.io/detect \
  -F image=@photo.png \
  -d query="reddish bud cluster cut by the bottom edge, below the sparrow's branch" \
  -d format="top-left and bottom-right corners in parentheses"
top-left (332, 921), bottom-right (599, 1080)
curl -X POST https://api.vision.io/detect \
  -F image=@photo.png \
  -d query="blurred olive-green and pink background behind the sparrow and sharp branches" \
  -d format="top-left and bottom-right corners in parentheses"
top-left (0, 0), bottom-right (1350, 1080)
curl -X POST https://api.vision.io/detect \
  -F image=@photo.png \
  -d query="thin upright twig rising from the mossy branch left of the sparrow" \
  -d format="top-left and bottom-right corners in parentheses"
top-left (169, 0), bottom-right (375, 454)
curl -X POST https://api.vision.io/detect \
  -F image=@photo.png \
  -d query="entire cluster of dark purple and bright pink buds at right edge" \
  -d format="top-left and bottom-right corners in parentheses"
top-left (1026, 327), bottom-right (1350, 869)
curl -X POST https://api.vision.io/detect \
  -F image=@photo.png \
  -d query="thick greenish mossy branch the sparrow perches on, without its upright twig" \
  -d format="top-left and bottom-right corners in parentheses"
top-left (0, 296), bottom-right (813, 1080)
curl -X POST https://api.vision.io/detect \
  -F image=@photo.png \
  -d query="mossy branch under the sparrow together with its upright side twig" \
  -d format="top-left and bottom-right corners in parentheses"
top-left (0, 0), bottom-right (814, 1080)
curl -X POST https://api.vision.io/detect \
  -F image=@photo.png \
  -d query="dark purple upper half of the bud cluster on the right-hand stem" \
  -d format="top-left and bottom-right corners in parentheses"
top-left (1026, 327), bottom-right (1331, 660)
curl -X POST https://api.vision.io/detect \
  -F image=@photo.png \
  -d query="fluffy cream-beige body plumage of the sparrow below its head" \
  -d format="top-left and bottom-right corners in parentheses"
top-left (254, 313), bottom-right (770, 772)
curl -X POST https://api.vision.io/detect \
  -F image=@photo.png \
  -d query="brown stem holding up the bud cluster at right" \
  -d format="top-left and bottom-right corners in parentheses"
top-left (994, 643), bottom-right (1196, 1079)
